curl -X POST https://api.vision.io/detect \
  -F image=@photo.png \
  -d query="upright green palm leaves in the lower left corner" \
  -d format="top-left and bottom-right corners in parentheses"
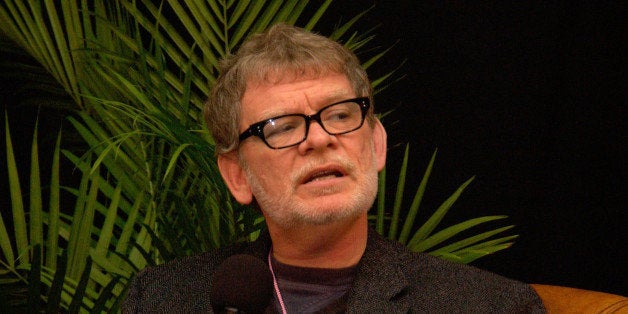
top-left (0, 118), bottom-right (145, 312)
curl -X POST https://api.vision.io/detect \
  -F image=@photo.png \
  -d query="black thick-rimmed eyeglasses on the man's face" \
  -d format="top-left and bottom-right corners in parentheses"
top-left (239, 97), bottom-right (371, 149)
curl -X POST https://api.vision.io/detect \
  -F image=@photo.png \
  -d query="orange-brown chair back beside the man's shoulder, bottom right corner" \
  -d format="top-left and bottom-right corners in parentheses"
top-left (531, 284), bottom-right (628, 314)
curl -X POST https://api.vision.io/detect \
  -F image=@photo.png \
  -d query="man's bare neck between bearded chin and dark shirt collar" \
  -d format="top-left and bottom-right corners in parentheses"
top-left (268, 214), bottom-right (368, 268)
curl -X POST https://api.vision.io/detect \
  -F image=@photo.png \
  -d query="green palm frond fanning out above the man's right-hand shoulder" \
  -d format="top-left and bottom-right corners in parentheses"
top-left (371, 146), bottom-right (517, 264)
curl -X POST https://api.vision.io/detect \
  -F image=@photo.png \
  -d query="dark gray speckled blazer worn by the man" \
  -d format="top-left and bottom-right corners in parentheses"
top-left (123, 230), bottom-right (545, 313)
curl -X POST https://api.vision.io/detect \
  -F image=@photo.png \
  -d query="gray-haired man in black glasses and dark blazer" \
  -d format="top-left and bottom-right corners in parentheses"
top-left (125, 25), bottom-right (543, 313)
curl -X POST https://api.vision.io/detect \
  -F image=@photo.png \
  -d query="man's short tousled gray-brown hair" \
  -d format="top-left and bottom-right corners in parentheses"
top-left (204, 24), bottom-right (375, 154)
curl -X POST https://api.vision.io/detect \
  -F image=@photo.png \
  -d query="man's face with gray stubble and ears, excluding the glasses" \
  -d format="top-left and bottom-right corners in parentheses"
top-left (219, 74), bottom-right (386, 227)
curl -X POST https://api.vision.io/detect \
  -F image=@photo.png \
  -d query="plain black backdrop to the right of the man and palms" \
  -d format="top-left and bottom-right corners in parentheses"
top-left (328, 0), bottom-right (628, 295)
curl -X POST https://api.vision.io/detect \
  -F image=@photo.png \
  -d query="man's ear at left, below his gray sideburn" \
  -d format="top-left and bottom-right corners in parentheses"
top-left (218, 152), bottom-right (253, 204)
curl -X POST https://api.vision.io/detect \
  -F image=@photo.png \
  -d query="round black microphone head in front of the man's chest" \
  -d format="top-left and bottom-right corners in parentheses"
top-left (210, 254), bottom-right (273, 313)
